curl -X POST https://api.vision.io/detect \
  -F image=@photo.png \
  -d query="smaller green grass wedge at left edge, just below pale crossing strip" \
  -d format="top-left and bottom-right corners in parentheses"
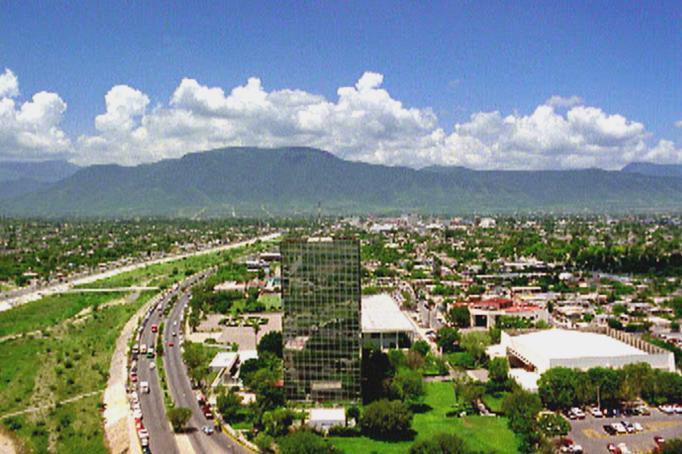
top-left (0, 293), bottom-right (118, 337)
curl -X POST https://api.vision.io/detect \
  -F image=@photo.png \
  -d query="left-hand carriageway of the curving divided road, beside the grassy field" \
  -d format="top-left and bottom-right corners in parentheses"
top-left (137, 295), bottom-right (180, 454)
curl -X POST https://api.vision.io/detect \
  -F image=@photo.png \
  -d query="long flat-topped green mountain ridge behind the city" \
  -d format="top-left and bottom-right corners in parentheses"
top-left (0, 147), bottom-right (682, 217)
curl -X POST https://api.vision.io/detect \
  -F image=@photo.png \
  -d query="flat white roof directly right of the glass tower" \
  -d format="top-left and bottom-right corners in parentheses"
top-left (362, 293), bottom-right (415, 333)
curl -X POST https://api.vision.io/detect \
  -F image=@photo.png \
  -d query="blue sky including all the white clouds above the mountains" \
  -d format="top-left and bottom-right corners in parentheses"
top-left (0, 0), bottom-right (682, 169)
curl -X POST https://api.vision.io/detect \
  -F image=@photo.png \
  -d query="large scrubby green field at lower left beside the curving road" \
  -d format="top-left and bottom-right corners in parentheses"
top-left (0, 302), bottom-right (147, 453)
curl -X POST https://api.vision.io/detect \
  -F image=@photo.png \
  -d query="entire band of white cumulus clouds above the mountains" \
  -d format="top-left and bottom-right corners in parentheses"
top-left (0, 70), bottom-right (682, 169)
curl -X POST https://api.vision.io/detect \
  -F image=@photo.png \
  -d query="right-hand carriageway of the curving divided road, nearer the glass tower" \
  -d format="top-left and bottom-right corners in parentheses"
top-left (163, 284), bottom-right (249, 454)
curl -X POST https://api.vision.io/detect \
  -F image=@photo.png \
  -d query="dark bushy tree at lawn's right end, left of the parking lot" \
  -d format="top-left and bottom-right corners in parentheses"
top-left (502, 389), bottom-right (542, 452)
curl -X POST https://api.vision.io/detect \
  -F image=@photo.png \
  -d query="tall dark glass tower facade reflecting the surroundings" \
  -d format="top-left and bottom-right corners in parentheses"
top-left (280, 238), bottom-right (362, 402)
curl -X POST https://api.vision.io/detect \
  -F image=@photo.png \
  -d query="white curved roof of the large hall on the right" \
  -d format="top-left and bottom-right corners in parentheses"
top-left (512, 329), bottom-right (646, 358)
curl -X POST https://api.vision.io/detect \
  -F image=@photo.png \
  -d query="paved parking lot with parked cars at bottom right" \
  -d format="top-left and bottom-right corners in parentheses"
top-left (568, 408), bottom-right (682, 454)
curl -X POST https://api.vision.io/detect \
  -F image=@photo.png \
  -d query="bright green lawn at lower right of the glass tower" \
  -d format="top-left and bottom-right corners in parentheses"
top-left (330, 382), bottom-right (518, 454)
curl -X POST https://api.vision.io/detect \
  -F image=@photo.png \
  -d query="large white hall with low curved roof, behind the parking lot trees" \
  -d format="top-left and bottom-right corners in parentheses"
top-left (489, 329), bottom-right (675, 390)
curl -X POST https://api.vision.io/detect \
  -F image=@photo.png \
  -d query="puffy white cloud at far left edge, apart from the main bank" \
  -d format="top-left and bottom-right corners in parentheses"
top-left (0, 69), bottom-right (71, 160)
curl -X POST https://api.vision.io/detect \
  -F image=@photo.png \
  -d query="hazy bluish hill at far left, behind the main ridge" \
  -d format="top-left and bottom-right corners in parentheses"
top-left (0, 161), bottom-right (80, 200)
